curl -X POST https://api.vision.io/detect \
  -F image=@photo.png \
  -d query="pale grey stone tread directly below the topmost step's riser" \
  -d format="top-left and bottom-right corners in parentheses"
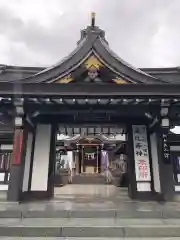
top-left (0, 218), bottom-right (170, 227)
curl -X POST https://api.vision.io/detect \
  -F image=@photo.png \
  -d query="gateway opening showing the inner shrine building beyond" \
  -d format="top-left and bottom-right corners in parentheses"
top-left (52, 126), bottom-right (128, 188)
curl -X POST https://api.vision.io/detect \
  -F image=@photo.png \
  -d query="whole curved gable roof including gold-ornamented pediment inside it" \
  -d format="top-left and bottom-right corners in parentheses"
top-left (0, 14), bottom-right (174, 84)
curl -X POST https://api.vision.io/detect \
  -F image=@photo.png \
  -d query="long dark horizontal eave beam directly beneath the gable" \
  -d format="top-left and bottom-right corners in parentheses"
top-left (0, 83), bottom-right (180, 99)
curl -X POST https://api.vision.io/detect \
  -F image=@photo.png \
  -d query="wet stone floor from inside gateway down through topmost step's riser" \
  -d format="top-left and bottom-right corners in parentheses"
top-left (0, 185), bottom-right (180, 219)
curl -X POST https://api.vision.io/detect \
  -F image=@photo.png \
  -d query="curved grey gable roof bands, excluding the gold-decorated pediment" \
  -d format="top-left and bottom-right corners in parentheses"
top-left (8, 22), bottom-right (172, 84)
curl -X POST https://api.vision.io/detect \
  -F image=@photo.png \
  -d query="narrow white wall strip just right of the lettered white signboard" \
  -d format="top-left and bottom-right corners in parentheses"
top-left (150, 133), bottom-right (161, 193)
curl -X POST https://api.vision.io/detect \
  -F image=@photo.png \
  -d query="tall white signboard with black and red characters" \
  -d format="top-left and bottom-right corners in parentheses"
top-left (132, 125), bottom-right (151, 182)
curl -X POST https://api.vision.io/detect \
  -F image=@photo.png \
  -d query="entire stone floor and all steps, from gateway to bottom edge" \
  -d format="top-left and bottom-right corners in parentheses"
top-left (0, 185), bottom-right (180, 237)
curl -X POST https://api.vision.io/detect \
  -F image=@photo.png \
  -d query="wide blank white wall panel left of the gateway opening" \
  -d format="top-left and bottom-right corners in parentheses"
top-left (31, 124), bottom-right (51, 191)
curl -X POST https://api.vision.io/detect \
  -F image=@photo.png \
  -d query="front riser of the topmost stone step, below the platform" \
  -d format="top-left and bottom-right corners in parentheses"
top-left (0, 209), bottom-right (170, 219)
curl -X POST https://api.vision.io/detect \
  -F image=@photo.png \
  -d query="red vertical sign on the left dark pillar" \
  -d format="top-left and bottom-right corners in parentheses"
top-left (12, 129), bottom-right (23, 165)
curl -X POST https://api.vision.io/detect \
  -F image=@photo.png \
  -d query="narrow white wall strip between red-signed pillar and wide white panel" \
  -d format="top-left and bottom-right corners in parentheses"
top-left (22, 133), bottom-right (33, 192)
